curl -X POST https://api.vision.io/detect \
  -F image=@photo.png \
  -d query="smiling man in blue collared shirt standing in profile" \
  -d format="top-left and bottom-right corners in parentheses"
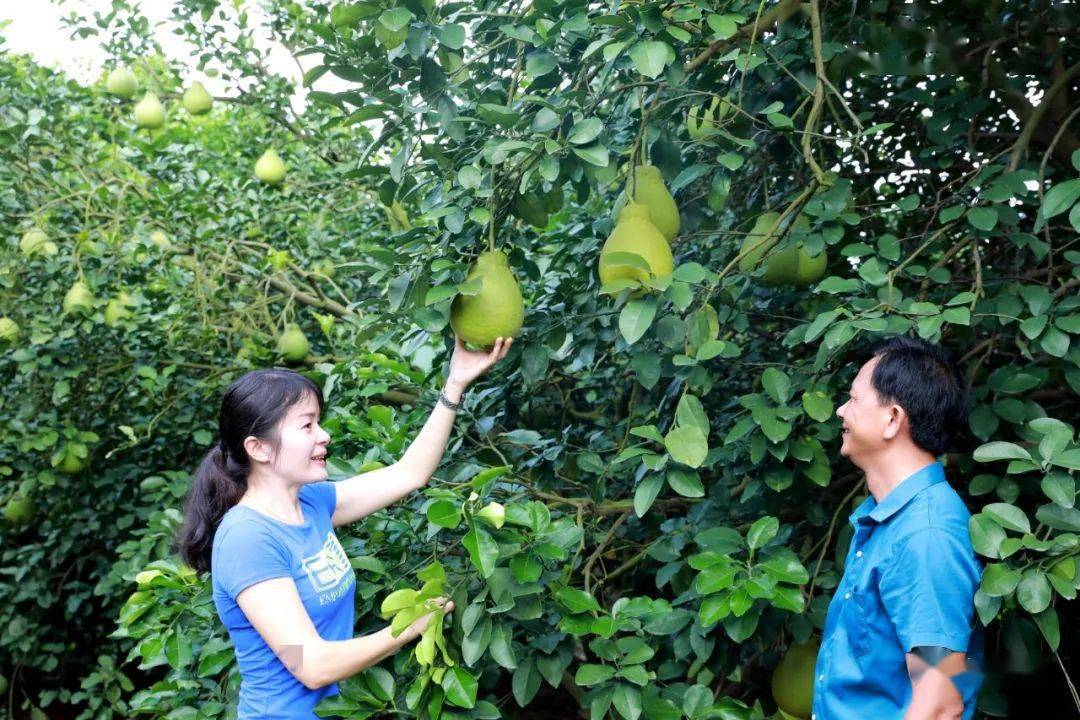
top-left (812, 337), bottom-right (982, 720)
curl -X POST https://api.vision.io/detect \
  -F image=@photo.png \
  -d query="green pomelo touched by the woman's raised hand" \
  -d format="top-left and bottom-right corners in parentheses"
top-left (450, 250), bottom-right (525, 348)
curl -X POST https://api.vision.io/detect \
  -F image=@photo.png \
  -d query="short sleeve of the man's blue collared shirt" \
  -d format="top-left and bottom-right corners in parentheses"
top-left (879, 528), bottom-right (980, 652)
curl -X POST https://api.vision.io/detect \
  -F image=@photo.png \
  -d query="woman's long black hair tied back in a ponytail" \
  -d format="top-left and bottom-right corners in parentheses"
top-left (176, 368), bottom-right (323, 572)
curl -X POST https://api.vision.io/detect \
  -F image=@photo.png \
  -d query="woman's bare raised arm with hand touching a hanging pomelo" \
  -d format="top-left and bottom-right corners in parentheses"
top-left (332, 337), bottom-right (514, 526)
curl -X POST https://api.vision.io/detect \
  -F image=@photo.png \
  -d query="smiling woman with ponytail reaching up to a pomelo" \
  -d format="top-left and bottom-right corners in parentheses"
top-left (179, 338), bottom-right (513, 720)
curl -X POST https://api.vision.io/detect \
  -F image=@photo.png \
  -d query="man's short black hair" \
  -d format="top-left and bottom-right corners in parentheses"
top-left (870, 335), bottom-right (968, 456)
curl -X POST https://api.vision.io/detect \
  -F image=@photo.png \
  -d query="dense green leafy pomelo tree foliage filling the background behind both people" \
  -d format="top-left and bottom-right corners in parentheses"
top-left (0, 0), bottom-right (1080, 720)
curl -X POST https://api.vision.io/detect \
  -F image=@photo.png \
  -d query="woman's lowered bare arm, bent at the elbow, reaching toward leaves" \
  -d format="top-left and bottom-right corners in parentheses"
top-left (237, 578), bottom-right (454, 690)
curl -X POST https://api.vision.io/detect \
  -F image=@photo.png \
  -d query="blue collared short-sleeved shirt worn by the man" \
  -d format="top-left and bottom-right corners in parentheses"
top-left (813, 462), bottom-right (983, 720)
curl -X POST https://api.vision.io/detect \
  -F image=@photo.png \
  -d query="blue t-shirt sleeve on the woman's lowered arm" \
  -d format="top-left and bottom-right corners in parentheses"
top-left (211, 522), bottom-right (293, 600)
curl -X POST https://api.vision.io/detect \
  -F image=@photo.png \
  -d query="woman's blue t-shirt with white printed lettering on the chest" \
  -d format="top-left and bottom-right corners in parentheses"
top-left (211, 481), bottom-right (356, 720)
